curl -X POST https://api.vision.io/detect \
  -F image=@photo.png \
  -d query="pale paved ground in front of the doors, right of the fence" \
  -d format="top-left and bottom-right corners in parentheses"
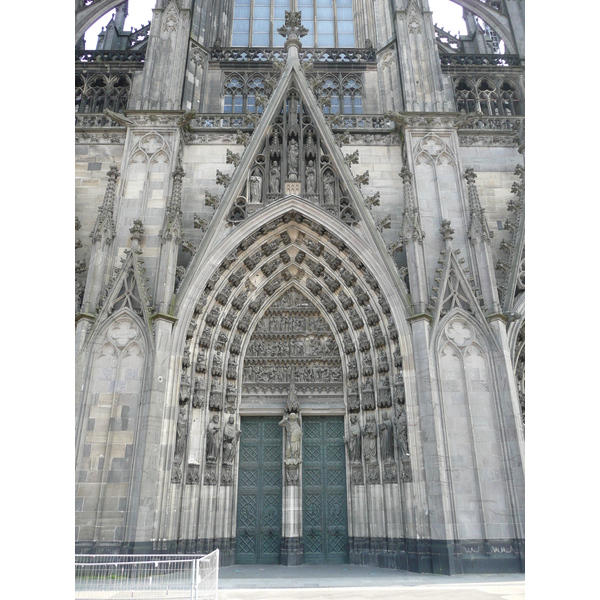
top-left (219, 565), bottom-right (525, 600)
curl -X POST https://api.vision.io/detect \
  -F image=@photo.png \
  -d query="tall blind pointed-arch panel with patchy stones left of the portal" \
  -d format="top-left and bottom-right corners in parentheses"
top-left (76, 308), bottom-right (148, 546)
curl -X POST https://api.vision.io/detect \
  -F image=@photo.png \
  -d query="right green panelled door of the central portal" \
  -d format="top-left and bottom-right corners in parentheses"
top-left (302, 417), bottom-right (348, 564)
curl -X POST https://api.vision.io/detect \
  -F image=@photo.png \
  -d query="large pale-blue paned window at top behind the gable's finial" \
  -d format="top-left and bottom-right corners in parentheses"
top-left (231, 0), bottom-right (354, 48)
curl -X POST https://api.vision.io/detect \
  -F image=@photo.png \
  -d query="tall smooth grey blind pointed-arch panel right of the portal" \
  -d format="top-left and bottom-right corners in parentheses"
top-left (436, 309), bottom-right (522, 554)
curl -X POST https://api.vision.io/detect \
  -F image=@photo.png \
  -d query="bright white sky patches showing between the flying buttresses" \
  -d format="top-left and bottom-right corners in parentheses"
top-left (85, 0), bottom-right (467, 50)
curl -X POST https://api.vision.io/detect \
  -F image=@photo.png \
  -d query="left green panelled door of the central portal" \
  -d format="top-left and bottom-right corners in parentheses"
top-left (236, 417), bottom-right (283, 565)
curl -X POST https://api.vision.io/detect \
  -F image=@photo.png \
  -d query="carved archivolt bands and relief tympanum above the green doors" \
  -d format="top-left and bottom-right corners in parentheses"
top-left (171, 212), bottom-right (410, 482)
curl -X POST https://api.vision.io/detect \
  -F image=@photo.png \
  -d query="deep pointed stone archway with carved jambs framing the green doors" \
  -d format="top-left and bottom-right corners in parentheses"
top-left (165, 209), bottom-right (412, 560)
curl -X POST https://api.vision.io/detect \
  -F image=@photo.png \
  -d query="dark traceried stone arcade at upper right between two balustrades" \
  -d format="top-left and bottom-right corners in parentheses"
top-left (454, 77), bottom-right (523, 117)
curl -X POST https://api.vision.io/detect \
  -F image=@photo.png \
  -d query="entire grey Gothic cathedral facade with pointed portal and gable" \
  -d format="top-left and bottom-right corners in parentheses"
top-left (75, 0), bottom-right (525, 574)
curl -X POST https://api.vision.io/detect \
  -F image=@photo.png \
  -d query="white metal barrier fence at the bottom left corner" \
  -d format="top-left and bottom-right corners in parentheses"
top-left (75, 550), bottom-right (219, 600)
